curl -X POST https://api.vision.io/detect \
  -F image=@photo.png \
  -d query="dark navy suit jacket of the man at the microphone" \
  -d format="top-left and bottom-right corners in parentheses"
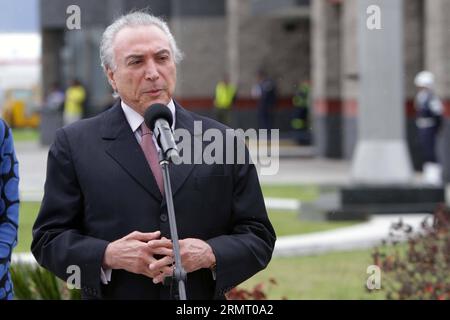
top-left (31, 102), bottom-right (275, 299)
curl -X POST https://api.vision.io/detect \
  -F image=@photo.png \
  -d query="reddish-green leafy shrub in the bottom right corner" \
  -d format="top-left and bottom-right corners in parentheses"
top-left (372, 206), bottom-right (450, 300)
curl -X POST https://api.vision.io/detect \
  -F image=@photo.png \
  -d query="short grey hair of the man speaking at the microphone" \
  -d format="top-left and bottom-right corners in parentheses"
top-left (100, 11), bottom-right (183, 72)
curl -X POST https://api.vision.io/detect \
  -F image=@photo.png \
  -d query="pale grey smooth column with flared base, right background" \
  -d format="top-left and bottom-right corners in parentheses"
top-left (352, 0), bottom-right (412, 185)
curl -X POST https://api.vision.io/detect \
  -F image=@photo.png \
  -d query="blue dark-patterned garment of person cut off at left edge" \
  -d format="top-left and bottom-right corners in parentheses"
top-left (0, 119), bottom-right (19, 300)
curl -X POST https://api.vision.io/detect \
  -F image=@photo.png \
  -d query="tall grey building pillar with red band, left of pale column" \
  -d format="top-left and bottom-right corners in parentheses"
top-left (311, 0), bottom-right (342, 158)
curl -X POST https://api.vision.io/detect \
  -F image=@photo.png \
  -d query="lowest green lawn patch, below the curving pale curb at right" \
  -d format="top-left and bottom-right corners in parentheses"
top-left (239, 250), bottom-right (385, 300)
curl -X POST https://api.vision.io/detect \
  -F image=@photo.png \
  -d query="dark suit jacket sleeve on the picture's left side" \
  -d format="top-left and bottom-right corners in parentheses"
top-left (31, 129), bottom-right (108, 297)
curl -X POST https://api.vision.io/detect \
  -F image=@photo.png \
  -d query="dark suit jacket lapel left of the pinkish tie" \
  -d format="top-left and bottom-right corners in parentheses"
top-left (100, 100), bottom-right (162, 201)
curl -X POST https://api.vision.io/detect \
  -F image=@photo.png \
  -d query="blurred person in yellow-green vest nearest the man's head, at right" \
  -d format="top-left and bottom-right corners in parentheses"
top-left (214, 76), bottom-right (236, 126)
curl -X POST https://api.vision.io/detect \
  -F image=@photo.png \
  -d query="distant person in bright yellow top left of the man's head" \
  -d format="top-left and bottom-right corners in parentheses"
top-left (64, 79), bottom-right (86, 125)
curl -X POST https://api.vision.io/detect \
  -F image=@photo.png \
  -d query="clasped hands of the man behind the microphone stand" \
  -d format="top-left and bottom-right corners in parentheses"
top-left (102, 231), bottom-right (216, 284)
